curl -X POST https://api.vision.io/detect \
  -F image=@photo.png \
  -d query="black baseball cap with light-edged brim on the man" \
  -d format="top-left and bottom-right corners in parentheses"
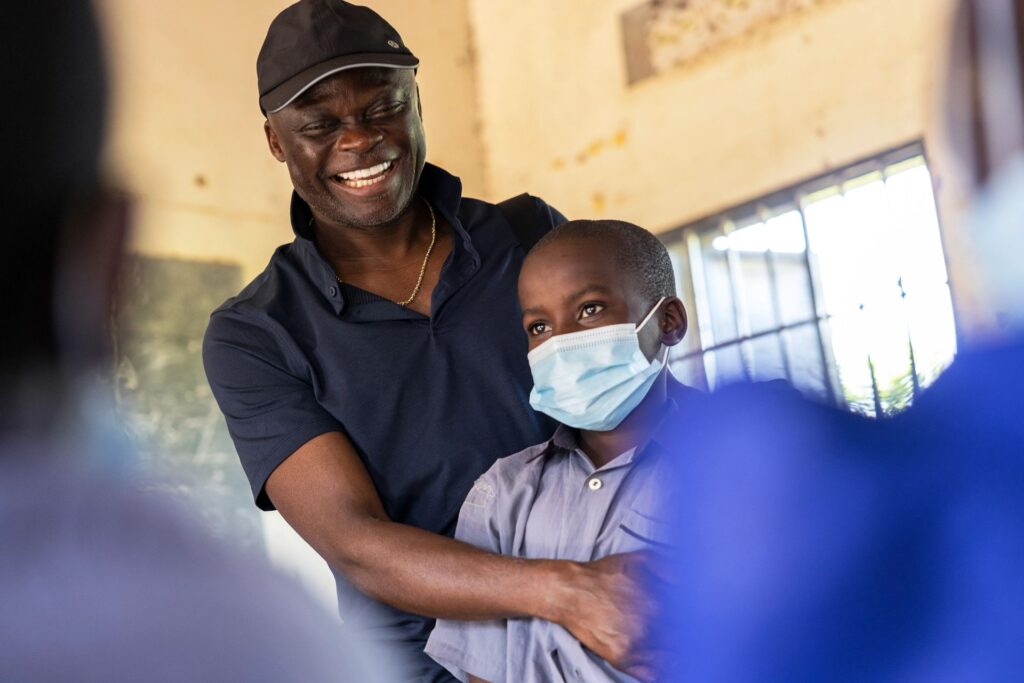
top-left (256, 0), bottom-right (420, 115)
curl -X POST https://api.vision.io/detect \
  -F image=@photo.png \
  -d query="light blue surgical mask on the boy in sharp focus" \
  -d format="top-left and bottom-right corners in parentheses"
top-left (527, 297), bottom-right (669, 431)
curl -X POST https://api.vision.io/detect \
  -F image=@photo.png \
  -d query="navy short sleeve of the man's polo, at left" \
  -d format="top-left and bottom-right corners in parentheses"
top-left (203, 310), bottom-right (343, 510)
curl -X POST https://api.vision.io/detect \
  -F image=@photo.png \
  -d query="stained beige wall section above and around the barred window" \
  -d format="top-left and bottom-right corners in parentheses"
top-left (470, 0), bottom-right (986, 333)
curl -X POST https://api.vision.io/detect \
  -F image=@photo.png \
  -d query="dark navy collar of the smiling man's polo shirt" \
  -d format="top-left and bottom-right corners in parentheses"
top-left (289, 163), bottom-right (480, 315)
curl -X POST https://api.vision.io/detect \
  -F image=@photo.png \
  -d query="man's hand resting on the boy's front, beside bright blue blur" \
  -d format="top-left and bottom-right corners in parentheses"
top-left (563, 552), bottom-right (659, 681)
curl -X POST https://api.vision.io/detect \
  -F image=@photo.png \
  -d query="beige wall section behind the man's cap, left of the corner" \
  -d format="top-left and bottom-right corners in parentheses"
top-left (98, 0), bottom-right (484, 280)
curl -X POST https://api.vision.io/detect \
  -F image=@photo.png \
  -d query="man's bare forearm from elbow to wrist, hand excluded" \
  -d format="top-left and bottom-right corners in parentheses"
top-left (319, 520), bottom-right (587, 622)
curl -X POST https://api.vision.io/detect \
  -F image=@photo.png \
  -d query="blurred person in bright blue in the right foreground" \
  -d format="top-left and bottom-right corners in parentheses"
top-left (665, 0), bottom-right (1024, 683)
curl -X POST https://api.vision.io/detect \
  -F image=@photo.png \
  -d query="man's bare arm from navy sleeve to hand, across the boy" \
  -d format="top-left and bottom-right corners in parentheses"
top-left (266, 432), bottom-right (648, 669)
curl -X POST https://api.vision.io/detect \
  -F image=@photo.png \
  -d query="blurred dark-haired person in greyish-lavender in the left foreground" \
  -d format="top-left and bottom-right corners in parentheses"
top-left (0, 0), bottom-right (393, 683)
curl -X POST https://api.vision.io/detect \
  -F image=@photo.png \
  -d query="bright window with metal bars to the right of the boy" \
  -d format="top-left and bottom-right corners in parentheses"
top-left (663, 143), bottom-right (956, 417)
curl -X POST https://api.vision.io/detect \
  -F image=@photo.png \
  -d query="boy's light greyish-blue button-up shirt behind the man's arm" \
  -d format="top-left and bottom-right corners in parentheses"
top-left (426, 403), bottom-right (678, 683)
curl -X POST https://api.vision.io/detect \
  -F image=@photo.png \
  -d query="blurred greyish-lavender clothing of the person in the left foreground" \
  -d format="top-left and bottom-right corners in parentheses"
top-left (0, 395), bottom-right (400, 683)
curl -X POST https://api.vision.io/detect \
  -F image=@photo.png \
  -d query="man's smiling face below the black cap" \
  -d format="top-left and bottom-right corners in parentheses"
top-left (265, 68), bottom-right (426, 228)
